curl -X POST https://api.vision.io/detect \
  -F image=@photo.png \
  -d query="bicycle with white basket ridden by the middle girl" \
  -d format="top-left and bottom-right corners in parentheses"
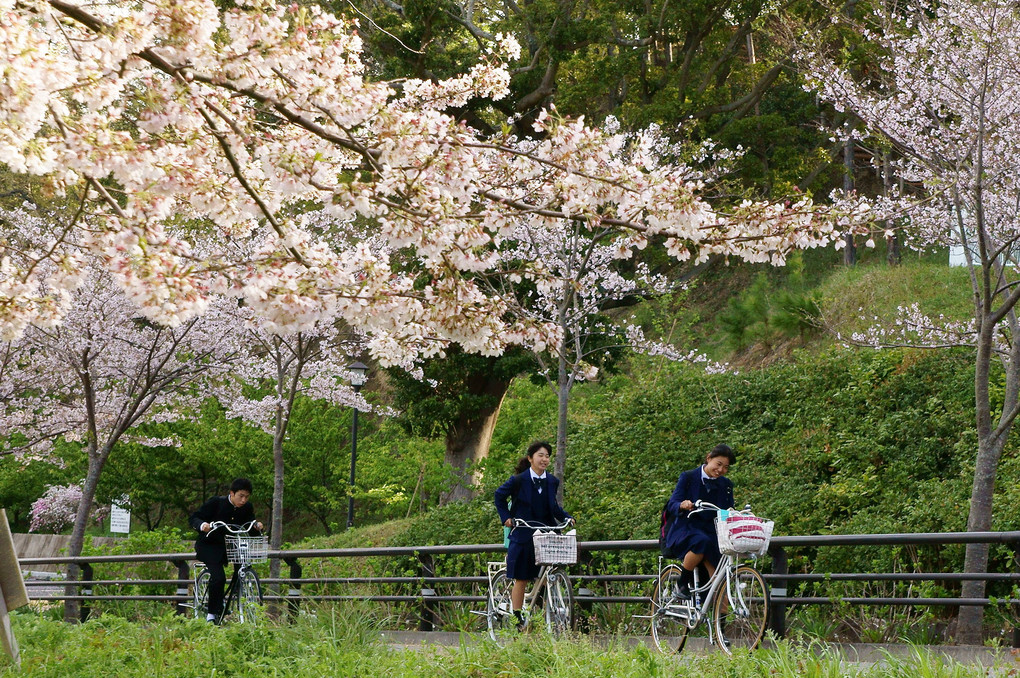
top-left (479, 519), bottom-right (577, 640)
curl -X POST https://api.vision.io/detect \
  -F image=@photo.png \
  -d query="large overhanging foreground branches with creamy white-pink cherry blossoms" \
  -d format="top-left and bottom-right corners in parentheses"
top-left (0, 0), bottom-right (860, 364)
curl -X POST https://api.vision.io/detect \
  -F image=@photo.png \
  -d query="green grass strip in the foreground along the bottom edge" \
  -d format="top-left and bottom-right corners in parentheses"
top-left (0, 607), bottom-right (1003, 678)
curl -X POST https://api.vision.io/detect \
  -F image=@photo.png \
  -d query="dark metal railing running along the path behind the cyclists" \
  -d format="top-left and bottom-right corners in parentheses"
top-left (20, 531), bottom-right (1020, 647)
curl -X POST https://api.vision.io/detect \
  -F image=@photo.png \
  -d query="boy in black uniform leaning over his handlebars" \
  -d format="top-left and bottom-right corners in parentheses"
top-left (188, 478), bottom-right (262, 622)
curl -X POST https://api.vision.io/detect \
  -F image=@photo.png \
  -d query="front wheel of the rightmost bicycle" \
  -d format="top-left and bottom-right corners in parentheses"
top-left (713, 565), bottom-right (769, 655)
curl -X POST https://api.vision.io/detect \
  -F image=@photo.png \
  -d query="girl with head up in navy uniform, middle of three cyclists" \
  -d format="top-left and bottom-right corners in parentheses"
top-left (496, 440), bottom-right (573, 626)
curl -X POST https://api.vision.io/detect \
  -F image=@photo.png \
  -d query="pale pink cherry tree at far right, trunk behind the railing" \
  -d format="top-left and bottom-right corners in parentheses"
top-left (803, 0), bottom-right (1020, 643)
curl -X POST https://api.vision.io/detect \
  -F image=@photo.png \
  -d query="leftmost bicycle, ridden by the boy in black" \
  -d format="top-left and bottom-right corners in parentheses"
top-left (191, 520), bottom-right (269, 625)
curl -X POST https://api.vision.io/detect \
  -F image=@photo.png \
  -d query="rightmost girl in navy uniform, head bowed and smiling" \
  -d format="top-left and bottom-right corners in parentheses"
top-left (666, 445), bottom-right (736, 595)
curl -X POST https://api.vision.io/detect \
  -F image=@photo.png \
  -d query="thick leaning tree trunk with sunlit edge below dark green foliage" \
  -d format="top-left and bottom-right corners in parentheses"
top-left (440, 380), bottom-right (510, 504)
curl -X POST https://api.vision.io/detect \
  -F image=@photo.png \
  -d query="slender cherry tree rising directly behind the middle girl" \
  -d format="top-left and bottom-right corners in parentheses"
top-left (501, 128), bottom-right (729, 491)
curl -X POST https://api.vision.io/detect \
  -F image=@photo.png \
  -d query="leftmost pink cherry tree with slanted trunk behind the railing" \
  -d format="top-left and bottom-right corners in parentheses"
top-left (0, 200), bottom-right (239, 619)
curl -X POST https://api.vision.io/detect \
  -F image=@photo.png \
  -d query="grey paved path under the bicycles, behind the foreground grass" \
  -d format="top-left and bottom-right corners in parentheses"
top-left (383, 631), bottom-right (1020, 671)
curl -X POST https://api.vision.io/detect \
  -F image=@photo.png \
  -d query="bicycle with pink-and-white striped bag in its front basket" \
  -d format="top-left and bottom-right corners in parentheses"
top-left (652, 501), bottom-right (772, 655)
